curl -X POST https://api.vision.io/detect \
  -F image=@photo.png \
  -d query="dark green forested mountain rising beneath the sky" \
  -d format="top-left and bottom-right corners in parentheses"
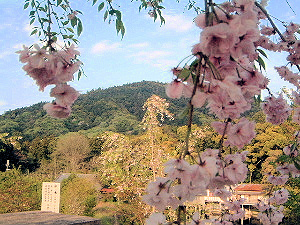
top-left (0, 81), bottom-right (217, 140)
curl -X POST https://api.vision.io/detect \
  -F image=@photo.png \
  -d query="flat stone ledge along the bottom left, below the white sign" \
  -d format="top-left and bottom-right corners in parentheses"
top-left (0, 211), bottom-right (100, 225)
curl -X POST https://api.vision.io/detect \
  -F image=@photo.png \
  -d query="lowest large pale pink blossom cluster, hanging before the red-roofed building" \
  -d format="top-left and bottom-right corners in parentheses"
top-left (143, 149), bottom-right (248, 224)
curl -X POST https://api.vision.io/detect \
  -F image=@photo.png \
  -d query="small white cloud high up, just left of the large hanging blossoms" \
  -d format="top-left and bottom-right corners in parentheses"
top-left (162, 14), bottom-right (194, 32)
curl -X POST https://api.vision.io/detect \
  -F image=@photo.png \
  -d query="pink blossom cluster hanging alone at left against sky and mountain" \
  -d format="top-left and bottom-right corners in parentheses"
top-left (17, 44), bottom-right (81, 118)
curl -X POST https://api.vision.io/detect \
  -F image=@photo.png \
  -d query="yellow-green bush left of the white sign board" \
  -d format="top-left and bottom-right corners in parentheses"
top-left (0, 169), bottom-right (42, 213)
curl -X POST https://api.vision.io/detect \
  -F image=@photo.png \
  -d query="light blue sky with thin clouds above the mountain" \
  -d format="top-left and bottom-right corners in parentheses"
top-left (0, 0), bottom-right (300, 114)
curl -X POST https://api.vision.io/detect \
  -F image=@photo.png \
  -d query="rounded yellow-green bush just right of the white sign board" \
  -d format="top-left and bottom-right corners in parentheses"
top-left (61, 175), bottom-right (97, 216)
